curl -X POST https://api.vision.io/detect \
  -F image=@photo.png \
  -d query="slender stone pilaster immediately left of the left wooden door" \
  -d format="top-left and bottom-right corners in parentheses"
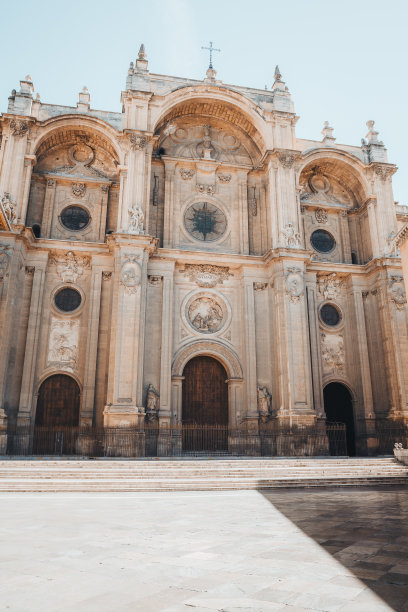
top-left (17, 253), bottom-right (48, 425)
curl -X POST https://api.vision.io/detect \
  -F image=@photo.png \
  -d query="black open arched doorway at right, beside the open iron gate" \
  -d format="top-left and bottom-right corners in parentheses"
top-left (323, 382), bottom-right (356, 456)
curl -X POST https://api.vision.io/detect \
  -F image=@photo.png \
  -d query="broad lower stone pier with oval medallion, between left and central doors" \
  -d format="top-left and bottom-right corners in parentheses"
top-left (104, 234), bottom-right (157, 426)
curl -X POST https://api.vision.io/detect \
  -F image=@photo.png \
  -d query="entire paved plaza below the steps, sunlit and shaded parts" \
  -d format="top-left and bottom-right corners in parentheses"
top-left (0, 487), bottom-right (408, 612)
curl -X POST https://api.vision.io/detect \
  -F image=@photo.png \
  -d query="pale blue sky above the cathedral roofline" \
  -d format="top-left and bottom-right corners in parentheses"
top-left (0, 0), bottom-right (408, 204)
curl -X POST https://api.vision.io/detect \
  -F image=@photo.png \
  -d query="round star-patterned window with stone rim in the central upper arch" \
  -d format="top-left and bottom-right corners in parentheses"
top-left (184, 202), bottom-right (227, 242)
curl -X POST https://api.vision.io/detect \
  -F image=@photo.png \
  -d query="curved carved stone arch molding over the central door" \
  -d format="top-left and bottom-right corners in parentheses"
top-left (172, 340), bottom-right (243, 381)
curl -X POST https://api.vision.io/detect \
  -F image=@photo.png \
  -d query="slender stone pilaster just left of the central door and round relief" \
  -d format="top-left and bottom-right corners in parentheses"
top-left (159, 262), bottom-right (175, 426)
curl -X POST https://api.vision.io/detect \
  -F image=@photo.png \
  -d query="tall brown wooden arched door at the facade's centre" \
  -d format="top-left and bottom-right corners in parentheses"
top-left (182, 355), bottom-right (228, 451)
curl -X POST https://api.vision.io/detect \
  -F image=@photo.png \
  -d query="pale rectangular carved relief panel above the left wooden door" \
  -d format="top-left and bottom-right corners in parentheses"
top-left (48, 317), bottom-right (79, 369)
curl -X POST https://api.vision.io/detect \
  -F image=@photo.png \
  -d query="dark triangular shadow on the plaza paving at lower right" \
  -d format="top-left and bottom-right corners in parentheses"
top-left (260, 486), bottom-right (408, 612)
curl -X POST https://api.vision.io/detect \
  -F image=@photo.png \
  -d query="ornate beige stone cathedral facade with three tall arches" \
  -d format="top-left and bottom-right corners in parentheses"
top-left (0, 46), bottom-right (408, 452)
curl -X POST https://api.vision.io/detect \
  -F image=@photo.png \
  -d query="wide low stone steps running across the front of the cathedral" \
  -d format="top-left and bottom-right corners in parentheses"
top-left (0, 457), bottom-right (408, 493)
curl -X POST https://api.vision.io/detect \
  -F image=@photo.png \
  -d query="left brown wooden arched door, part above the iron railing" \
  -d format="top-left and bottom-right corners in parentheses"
top-left (35, 374), bottom-right (80, 427)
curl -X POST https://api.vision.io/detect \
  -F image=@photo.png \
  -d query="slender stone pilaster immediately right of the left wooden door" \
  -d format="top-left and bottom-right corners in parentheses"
top-left (80, 262), bottom-right (103, 426)
